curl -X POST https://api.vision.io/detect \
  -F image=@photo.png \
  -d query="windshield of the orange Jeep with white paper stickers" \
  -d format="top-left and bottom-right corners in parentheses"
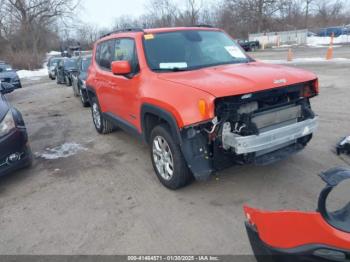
top-left (144, 30), bottom-right (250, 71)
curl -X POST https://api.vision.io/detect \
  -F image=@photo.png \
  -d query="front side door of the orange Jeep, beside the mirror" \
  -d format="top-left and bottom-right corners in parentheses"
top-left (110, 38), bottom-right (140, 128)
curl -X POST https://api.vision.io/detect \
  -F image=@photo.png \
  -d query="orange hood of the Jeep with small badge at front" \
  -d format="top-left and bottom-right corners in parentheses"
top-left (159, 62), bottom-right (317, 97)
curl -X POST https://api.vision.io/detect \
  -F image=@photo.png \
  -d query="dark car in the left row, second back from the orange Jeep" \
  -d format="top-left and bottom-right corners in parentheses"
top-left (56, 58), bottom-right (78, 86)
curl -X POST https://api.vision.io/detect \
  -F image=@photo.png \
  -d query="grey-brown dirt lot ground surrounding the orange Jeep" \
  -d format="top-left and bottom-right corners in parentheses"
top-left (0, 47), bottom-right (350, 255)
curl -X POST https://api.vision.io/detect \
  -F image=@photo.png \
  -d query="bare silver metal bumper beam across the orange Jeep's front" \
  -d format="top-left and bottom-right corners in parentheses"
top-left (222, 117), bottom-right (318, 155)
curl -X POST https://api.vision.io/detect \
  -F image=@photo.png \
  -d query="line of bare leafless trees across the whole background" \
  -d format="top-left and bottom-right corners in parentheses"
top-left (0, 0), bottom-right (350, 68)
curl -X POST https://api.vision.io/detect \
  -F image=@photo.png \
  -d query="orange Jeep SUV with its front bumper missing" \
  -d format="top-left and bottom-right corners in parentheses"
top-left (86, 27), bottom-right (319, 189)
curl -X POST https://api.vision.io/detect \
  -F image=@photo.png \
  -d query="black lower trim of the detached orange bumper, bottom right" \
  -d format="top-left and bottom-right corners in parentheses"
top-left (246, 223), bottom-right (350, 262)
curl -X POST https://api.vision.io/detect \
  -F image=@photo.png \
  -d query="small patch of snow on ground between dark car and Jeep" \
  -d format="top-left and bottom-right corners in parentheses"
top-left (40, 142), bottom-right (87, 160)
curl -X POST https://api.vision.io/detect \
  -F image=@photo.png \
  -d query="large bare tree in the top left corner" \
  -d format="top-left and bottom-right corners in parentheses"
top-left (1, 0), bottom-right (79, 68)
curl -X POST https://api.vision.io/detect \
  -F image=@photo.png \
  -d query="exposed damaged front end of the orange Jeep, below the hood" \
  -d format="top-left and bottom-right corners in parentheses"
top-left (182, 80), bottom-right (318, 180)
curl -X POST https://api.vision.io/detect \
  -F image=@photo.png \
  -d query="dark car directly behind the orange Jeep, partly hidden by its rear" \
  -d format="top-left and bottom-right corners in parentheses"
top-left (72, 56), bottom-right (91, 107)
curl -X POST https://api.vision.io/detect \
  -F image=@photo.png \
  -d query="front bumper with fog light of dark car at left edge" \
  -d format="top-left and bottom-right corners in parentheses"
top-left (0, 128), bottom-right (32, 176)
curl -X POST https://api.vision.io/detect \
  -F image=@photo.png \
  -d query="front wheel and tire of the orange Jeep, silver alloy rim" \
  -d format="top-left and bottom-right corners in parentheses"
top-left (150, 124), bottom-right (193, 190)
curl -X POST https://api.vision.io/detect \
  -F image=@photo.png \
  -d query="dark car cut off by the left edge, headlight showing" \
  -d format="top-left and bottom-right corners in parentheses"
top-left (0, 83), bottom-right (32, 176)
